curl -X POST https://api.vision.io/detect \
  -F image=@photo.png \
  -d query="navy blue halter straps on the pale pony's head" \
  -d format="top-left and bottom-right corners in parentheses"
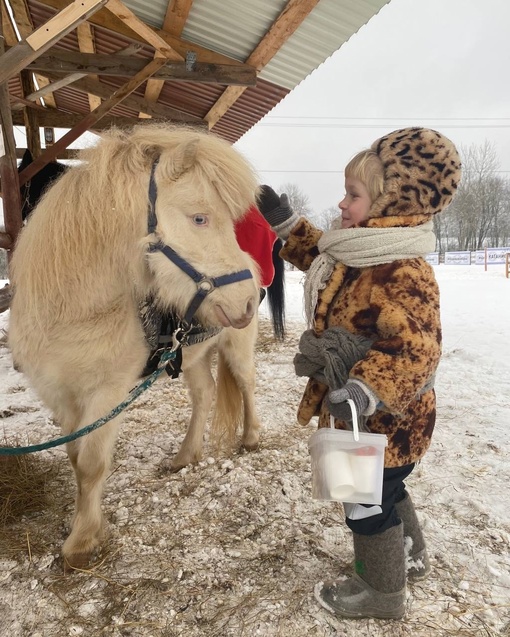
top-left (147, 159), bottom-right (253, 325)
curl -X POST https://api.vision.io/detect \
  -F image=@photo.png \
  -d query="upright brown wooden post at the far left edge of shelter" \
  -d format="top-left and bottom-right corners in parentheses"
top-left (0, 6), bottom-right (23, 259)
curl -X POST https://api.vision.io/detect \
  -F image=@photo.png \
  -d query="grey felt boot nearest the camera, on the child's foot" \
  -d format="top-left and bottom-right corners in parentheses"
top-left (314, 524), bottom-right (406, 619)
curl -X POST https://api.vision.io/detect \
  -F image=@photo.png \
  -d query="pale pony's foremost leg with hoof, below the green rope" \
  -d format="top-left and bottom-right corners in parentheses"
top-left (62, 396), bottom-right (122, 568)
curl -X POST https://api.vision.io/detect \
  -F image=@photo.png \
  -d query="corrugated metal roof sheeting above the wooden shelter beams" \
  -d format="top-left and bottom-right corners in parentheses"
top-left (9, 0), bottom-right (389, 142)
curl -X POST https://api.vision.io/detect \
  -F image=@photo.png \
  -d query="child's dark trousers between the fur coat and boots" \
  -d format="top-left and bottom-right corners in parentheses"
top-left (345, 464), bottom-right (414, 535)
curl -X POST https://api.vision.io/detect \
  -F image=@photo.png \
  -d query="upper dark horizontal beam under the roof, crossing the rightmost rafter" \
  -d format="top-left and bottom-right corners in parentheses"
top-left (27, 49), bottom-right (257, 86)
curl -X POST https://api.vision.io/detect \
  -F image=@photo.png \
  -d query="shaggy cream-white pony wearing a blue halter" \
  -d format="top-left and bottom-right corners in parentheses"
top-left (9, 124), bottom-right (259, 567)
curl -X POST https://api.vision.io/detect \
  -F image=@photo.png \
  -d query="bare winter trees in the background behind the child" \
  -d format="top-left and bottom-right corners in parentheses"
top-left (279, 141), bottom-right (510, 252)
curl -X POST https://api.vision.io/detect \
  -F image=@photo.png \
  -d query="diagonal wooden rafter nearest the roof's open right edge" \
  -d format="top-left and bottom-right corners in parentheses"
top-left (204, 0), bottom-right (319, 128)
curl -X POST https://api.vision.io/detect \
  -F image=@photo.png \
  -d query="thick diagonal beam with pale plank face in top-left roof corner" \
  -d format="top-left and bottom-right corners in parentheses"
top-left (0, 0), bottom-right (108, 84)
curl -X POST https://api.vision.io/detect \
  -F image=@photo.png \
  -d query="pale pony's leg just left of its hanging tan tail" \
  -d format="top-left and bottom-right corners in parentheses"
top-left (170, 344), bottom-right (215, 471)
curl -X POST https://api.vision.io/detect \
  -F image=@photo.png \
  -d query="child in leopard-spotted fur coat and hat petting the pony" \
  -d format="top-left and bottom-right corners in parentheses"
top-left (261, 128), bottom-right (460, 618)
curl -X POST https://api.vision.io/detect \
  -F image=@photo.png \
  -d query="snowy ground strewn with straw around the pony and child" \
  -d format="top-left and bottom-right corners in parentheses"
top-left (0, 265), bottom-right (510, 637)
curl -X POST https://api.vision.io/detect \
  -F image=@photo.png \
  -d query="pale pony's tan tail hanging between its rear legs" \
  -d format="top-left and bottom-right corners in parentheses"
top-left (211, 348), bottom-right (244, 455)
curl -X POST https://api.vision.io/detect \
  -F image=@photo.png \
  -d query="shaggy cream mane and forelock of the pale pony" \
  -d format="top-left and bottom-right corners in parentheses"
top-left (12, 124), bottom-right (257, 320)
